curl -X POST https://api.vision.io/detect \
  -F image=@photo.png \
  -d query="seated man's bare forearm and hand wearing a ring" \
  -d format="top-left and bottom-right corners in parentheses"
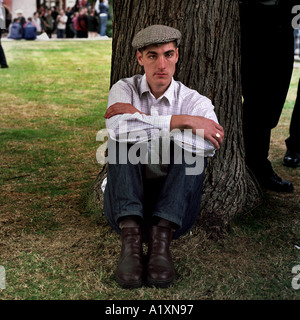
top-left (170, 114), bottom-right (224, 149)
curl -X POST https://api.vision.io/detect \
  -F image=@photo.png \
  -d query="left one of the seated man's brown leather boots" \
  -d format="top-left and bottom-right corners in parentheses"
top-left (115, 228), bottom-right (143, 289)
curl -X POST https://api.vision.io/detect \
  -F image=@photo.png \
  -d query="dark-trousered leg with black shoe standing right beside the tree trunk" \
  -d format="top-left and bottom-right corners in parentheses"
top-left (240, 0), bottom-right (294, 192)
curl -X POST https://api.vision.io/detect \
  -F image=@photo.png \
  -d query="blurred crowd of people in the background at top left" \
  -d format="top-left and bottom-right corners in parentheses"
top-left (2, 0), bottom-right (112, 40)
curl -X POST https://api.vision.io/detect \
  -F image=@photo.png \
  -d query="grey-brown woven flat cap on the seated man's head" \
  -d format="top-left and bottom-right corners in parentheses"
top-left (132, 24), bottom-right (181, 49)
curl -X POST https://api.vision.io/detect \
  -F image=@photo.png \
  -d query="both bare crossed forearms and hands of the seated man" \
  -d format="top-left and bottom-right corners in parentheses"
top-left (104, 102), bottom-right (224, 149)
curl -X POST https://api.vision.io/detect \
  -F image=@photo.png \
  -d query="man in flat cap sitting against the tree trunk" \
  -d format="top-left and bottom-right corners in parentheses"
top-left (104, 25), bottom-right (224, 288)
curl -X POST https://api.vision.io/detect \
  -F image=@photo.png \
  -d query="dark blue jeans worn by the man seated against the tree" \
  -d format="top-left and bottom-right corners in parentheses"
top-left (104, 143), bottom-right (207, 241)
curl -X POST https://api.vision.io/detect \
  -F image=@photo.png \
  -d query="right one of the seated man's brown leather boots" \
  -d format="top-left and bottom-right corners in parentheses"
top-left (147, 226), bottom-right (175, 288)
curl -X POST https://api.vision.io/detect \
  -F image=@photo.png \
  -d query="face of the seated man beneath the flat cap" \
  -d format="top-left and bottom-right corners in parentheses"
top-left (137, 42), bottom-right (178, 95)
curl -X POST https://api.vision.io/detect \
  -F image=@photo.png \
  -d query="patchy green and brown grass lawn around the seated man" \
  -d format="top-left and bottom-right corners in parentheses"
top-left (0, 41), bottom-right (300, 300)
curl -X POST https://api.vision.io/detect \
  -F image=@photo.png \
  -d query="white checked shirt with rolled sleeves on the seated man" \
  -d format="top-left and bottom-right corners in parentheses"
top-left (106, 75), bottom-right (218, 157)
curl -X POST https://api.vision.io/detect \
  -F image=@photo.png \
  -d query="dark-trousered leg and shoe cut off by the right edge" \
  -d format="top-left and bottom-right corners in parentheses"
top-left (283, 79), bottom-right (300, 168)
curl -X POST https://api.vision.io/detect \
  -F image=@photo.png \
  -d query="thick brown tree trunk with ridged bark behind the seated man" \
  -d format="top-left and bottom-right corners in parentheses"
top-left (94, 0), bottom-right (262, 233)
